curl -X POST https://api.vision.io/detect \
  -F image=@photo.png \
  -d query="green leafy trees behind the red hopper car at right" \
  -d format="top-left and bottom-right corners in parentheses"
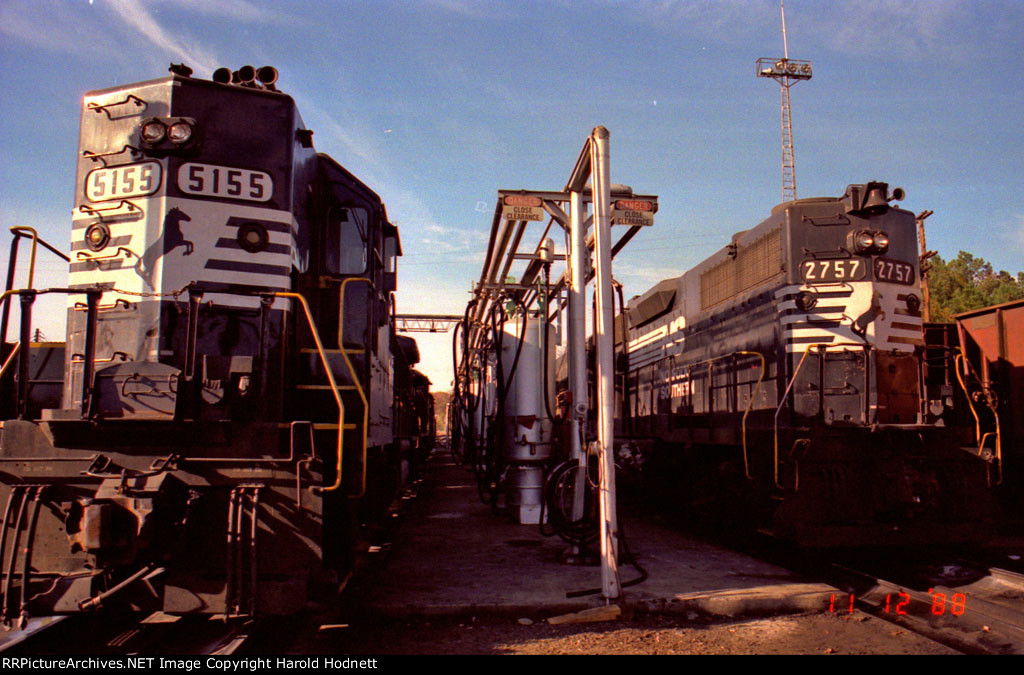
top-left (928, 251), bottom-right (1024, 322)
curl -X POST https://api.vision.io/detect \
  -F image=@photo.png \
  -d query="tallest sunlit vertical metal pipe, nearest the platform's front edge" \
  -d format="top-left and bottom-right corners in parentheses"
top-left (591, 127), bottom-right (621, 600)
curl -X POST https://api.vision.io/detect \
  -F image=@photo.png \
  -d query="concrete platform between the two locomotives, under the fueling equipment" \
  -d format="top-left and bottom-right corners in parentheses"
top-left (364, 450), bottom-right (836, 620)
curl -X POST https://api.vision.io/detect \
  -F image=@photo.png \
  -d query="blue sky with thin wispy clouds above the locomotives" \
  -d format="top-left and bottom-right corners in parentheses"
top-left (0, 0), bottom-right (1024, 388)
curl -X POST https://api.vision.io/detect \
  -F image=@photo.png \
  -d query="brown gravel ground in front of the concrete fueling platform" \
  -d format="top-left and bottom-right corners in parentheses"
top-left (304, 611), bottom-right (957, 656)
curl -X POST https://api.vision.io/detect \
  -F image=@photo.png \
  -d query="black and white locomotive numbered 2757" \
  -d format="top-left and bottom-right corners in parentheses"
top-left (618, 182), bottom-right (998, 546)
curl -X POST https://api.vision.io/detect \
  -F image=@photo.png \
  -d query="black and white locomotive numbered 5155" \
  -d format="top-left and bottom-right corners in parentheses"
top-left (0, 66), bottom-right (432, 624)
